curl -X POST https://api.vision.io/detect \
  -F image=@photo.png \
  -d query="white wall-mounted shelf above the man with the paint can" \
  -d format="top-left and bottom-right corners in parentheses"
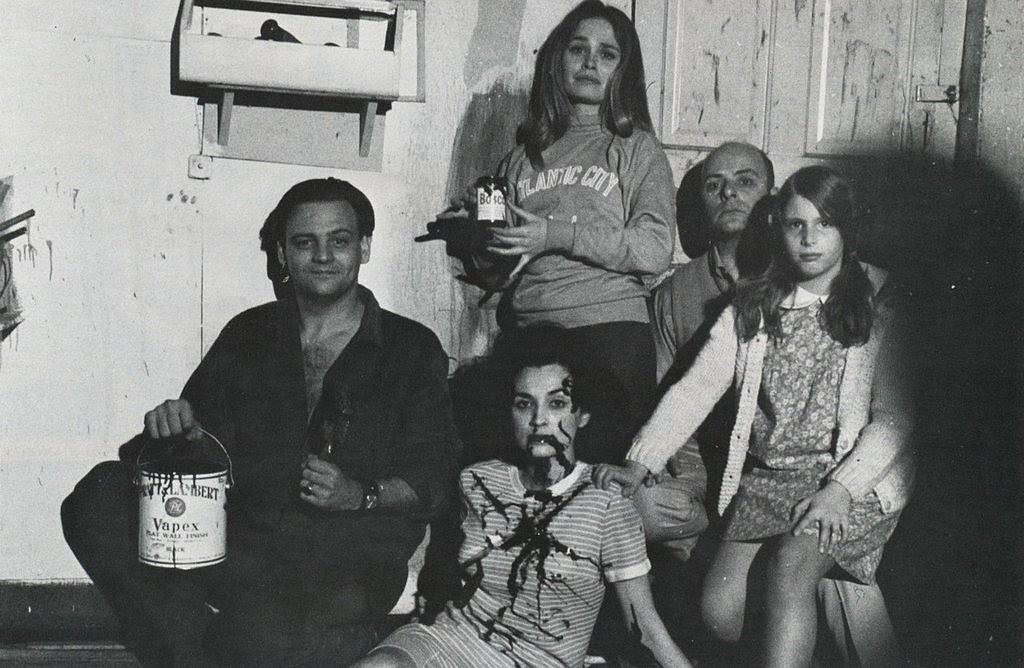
top-left (176, 0), bottom-right (424, 169)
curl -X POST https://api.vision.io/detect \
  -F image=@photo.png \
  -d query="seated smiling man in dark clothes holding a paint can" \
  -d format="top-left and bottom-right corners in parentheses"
top-left (61, 178), bottom-right (457, 665)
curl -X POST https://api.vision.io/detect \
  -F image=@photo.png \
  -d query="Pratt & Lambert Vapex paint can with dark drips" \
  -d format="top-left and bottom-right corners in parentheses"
top-left (135, 430), bottom-right (233, 571)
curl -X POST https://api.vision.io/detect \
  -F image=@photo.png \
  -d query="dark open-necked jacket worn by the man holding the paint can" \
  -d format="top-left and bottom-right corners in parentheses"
top-left (182, 287), bottom-right (457, 611)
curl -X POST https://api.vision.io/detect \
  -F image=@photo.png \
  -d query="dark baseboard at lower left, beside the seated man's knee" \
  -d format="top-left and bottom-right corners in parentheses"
top-left (0, 581), bottom-right (118, 644)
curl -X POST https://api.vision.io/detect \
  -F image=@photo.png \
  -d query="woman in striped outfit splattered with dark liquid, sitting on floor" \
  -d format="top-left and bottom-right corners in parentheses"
top-left (356, 328), bottom-right (690, 668)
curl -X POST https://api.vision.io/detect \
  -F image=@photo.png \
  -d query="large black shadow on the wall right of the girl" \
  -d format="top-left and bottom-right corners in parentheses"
top-left (846, 152), bottom-right (1024, 665)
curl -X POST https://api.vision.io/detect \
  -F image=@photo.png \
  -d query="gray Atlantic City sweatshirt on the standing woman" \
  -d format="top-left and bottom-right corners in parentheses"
top-left (500, 116), bottom-right (676, 327)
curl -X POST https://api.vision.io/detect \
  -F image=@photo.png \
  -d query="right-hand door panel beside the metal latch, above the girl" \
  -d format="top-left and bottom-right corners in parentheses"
top-left (804, 0), bottom-right (963, 157)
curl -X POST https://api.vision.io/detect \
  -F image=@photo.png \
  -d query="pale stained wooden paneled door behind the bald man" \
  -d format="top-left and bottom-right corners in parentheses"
top-left (636, 0), bottom-right (967, 166)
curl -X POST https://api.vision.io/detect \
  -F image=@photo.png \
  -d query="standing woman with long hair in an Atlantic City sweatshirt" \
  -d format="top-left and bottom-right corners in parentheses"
top-left (490, 0), bottom-right (675, 462)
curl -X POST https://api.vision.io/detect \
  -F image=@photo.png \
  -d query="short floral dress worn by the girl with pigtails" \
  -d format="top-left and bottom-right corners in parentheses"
top-left (724, 299), bottom-right (899, 583)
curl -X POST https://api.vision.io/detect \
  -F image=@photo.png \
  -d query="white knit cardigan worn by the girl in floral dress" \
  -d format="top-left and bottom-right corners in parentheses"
top-left (627, 276), bottom-right (914, 513)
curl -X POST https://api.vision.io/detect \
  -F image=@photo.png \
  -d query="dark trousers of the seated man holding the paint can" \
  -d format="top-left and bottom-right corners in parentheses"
top-left (60, 461), bottom-right (387, 666)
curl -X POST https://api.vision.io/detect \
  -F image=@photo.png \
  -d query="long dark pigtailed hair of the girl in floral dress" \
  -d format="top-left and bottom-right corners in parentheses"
top-left (734, 166), bottom-right (874, 346)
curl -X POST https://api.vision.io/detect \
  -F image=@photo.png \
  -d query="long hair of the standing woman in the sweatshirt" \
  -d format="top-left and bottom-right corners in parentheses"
top-left (517, 0), bottom-right (651, 169)
